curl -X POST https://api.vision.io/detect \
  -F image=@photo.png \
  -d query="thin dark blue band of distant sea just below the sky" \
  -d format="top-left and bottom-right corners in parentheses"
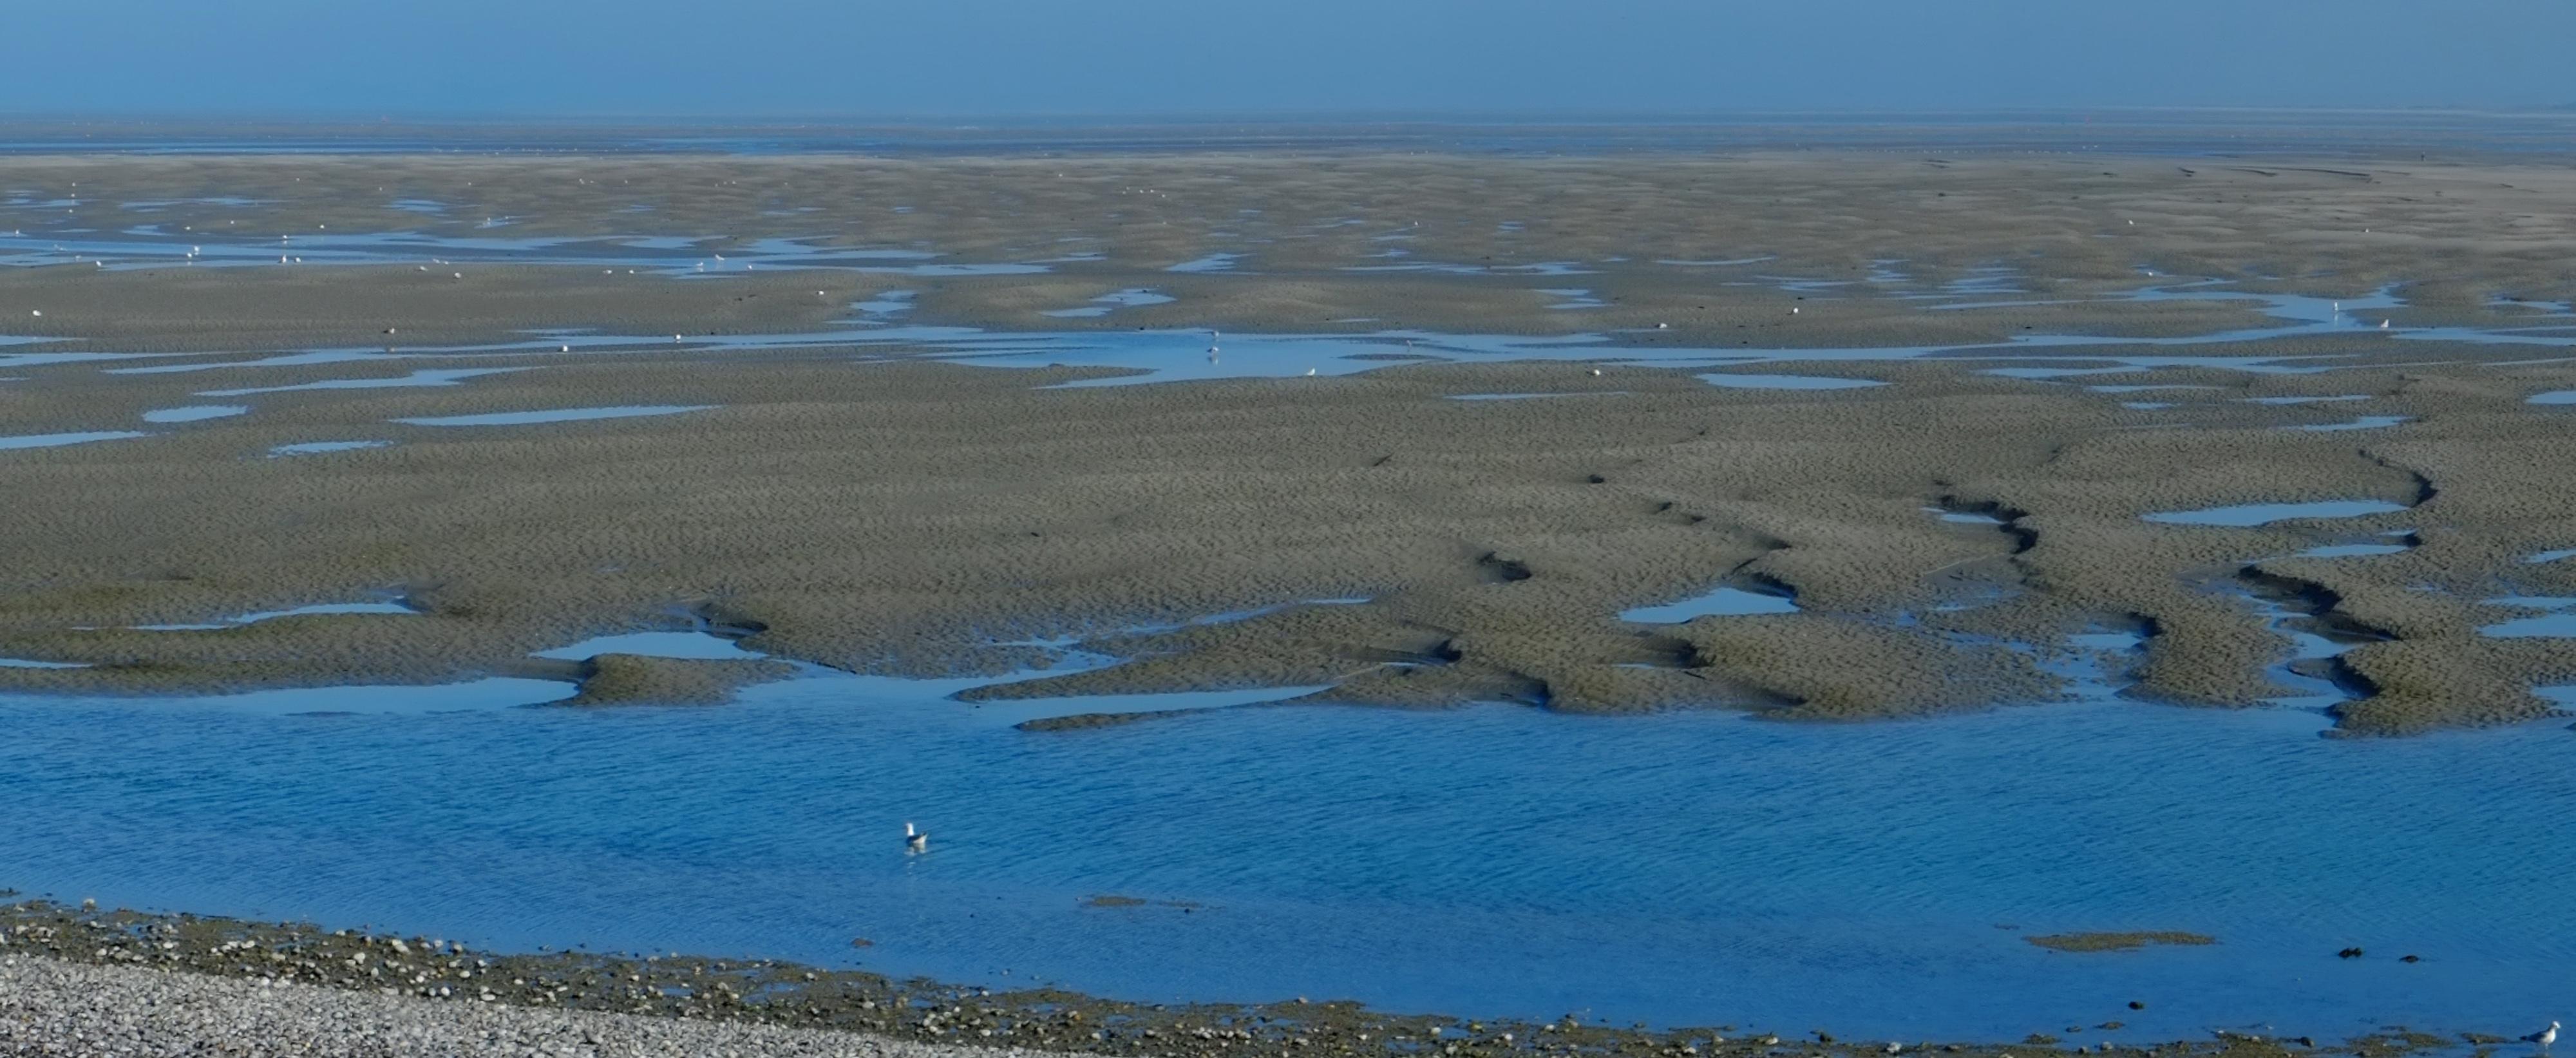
top-left (0, 108), bottom-right (2576, 157)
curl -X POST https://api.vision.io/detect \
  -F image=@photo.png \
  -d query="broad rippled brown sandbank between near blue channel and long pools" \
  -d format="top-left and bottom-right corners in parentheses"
top-left (15, 337), bottom-right (2576, 731)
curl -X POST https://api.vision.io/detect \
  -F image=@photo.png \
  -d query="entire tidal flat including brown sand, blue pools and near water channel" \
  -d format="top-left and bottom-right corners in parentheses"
top-left (0, 128), bottom-right (2576, 1050)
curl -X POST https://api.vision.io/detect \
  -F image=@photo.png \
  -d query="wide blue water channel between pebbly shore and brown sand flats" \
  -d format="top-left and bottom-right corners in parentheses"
top-left (0, 654), bottom-right (2576, 1043)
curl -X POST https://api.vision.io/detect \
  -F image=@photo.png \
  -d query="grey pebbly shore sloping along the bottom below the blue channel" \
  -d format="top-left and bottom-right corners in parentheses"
top-left (0, 901), bottom-right (2463, 1058)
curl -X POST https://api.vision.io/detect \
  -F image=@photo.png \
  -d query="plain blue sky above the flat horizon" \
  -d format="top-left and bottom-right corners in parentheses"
top-left (0, 0), bottom-right (2576, 116)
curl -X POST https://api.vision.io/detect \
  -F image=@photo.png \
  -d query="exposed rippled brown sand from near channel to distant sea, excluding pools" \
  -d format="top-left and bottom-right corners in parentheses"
top-left (0, 152), bottom-right (2576, 733)
